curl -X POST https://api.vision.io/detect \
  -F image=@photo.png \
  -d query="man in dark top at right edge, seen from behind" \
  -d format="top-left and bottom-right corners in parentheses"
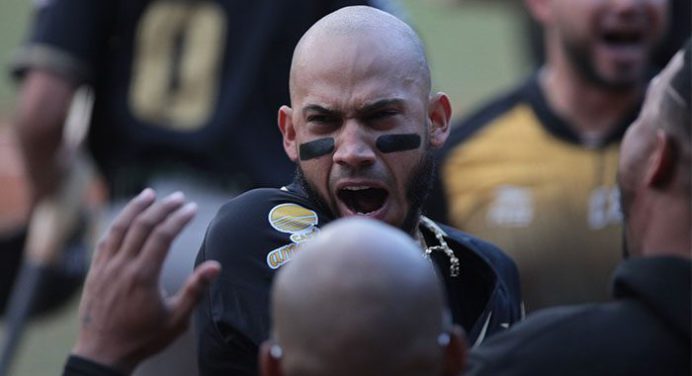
top-left (467, 42), bottom-right (692, 376)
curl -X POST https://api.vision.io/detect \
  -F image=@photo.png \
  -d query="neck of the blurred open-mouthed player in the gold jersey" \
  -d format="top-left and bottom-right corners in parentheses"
top-left (539, 39), bottom-right (643, 142)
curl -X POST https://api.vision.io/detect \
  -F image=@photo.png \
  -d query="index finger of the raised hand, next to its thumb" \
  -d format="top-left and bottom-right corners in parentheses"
top-left (139, 202), bottom-right (197, 276)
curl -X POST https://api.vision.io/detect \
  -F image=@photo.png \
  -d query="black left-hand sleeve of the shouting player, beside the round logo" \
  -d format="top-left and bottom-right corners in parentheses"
top-left (195, 196), bottom-right (282, 376)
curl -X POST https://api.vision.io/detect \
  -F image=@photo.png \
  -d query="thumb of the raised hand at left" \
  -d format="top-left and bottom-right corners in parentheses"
top-left (169, 260), bottom-right (221, 328)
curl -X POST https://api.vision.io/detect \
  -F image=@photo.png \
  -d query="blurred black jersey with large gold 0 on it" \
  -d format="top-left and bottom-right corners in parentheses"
top-left (15, 0), bottom-right (384, 196)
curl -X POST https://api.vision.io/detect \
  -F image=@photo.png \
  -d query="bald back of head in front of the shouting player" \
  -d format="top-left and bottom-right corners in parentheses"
top-left (261, 218), bottom-right (465, 376)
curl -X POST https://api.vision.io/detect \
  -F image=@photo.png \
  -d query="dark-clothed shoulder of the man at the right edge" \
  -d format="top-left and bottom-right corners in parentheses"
top-left (465, 299), bottom-right (690, 375)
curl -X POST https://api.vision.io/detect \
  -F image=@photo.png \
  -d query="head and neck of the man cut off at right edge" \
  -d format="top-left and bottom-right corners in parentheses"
top-left (618, 43), bottom-right (692, 257)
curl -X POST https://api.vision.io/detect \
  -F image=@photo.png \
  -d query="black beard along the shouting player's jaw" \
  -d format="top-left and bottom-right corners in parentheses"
top-left (295, 151), bottom-right (435, 235)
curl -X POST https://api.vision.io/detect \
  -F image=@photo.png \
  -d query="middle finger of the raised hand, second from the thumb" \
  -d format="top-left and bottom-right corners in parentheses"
top-left (120, 192), bottom-right (185, 257)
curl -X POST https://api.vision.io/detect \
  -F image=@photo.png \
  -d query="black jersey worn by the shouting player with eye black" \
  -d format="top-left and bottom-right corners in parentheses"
top-left (195, 183), bottom-right (521, 376)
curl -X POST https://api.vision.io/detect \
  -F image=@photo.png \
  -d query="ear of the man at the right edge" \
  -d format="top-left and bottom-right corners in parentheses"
top-left (645, 129), bottom-right (677, 188)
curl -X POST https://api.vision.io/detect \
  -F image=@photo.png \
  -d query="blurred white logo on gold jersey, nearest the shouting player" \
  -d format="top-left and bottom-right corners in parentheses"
top-left (487, 185), bottom-right (534, 227)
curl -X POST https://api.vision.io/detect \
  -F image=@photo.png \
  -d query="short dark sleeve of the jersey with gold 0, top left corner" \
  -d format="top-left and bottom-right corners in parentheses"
top-left (12, 0), bottom-right (118, 82)
